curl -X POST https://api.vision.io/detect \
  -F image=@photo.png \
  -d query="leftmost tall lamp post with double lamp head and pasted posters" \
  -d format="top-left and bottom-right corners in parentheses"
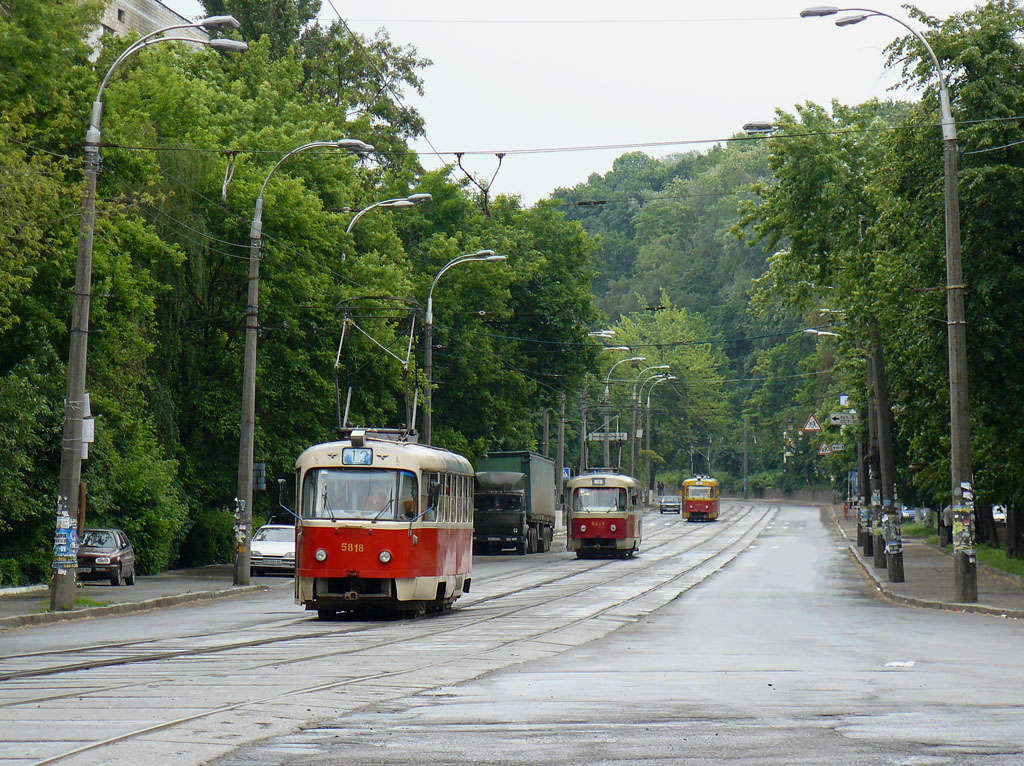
top-left (50, 15), bottom-right (249, 610)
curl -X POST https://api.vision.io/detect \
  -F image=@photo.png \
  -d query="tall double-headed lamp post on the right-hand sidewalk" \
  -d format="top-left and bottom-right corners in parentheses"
top-left (800, 5), bottom-right (978, 603)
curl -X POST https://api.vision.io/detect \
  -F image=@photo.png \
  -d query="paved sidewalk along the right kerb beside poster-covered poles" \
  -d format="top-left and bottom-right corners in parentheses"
top-left (824, 506), bottom-right (1024, 619)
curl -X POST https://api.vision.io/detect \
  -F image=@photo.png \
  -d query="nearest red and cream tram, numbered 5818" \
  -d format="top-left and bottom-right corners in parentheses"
top-left (295, 429), bottom-right (473, 618)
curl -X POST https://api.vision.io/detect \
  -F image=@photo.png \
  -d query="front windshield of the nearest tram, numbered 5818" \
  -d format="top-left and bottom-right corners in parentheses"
top-left (302, 468), bottom-right (418, 521)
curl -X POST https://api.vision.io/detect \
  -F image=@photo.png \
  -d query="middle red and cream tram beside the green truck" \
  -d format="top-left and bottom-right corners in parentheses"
top-left (565, 473), bottom-right (643, 558)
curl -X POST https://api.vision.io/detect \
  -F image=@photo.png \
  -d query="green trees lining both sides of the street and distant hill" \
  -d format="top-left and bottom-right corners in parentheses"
top-left (0, 0), bottom-right (1024, 585)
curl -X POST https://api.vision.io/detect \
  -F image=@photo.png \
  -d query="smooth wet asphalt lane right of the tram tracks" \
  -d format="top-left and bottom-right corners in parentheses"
top-left (216, 506), bottom-right (1024, 766)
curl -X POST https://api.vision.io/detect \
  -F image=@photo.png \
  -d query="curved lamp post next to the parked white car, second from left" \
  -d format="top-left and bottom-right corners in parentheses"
top-left (232, 138), bottom-right (374, 585)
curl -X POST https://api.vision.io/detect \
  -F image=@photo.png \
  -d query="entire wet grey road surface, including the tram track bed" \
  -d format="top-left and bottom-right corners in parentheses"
top-left (0, 503), bottom-right (1024, 766)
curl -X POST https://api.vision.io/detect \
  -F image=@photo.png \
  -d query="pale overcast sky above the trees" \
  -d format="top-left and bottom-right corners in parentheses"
top-left (164, 0), bottom-right (978, 204)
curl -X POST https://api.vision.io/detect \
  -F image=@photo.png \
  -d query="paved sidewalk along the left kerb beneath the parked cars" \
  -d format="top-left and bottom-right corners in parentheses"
top-left (0, 564), bottom-right (276, 631)
